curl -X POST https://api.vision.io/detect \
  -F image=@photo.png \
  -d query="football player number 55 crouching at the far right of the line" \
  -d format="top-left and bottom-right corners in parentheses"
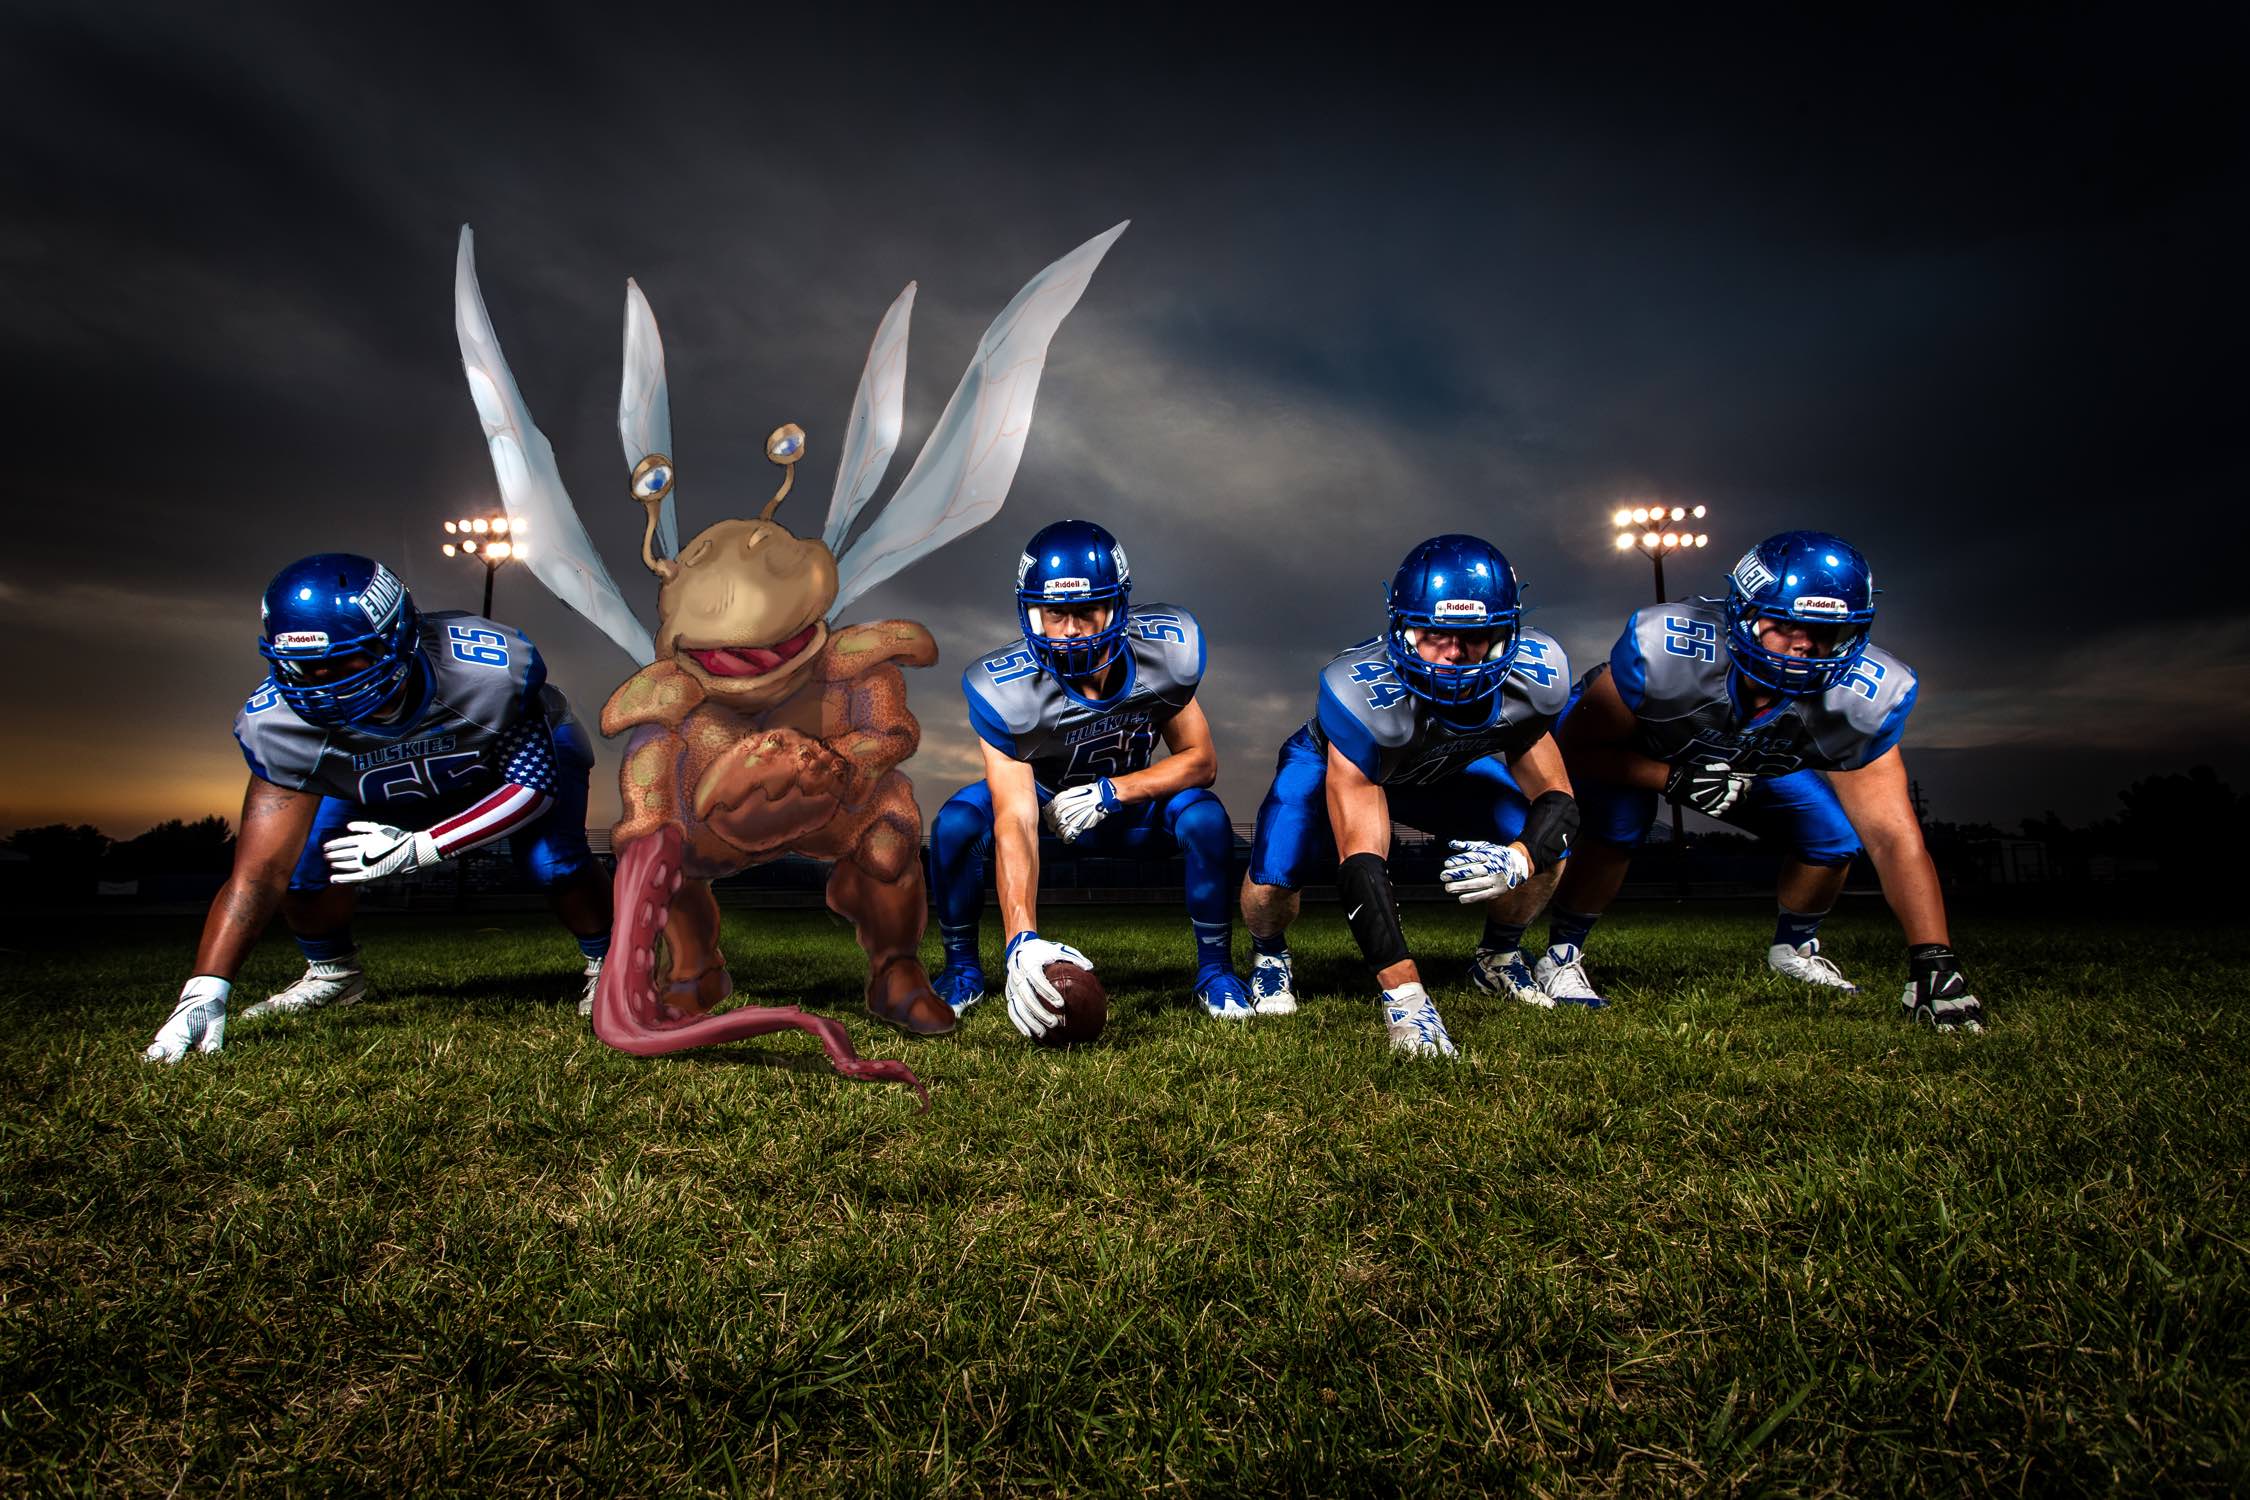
top-left (1537, 531), bottom-right (1985, 1032)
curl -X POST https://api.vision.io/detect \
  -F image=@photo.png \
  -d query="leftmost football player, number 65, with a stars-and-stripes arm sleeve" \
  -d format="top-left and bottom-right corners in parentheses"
top-left (149, 553), bottom-right (610, 1061)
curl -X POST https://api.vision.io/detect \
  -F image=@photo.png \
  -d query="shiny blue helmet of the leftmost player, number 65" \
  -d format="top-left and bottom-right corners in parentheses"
top-left (259, 553), bottom-right (421, 724)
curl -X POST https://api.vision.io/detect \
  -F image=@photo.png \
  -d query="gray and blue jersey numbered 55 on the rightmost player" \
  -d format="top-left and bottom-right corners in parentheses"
top-left (1589, 600), bottom-right (1915, 778)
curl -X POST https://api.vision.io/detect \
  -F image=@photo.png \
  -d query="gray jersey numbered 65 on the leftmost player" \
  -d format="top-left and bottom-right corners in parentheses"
top-left (234, 609), bottom-right (585, 807)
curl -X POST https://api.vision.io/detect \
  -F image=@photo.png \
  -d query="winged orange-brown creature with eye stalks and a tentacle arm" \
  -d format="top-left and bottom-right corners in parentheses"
top-left (455, 225), bottom-right (1125, 1097)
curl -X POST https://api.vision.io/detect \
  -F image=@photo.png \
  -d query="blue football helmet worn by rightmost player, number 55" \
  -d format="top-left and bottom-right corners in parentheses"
top-left (1726, 531), bottom-right (1874, 695)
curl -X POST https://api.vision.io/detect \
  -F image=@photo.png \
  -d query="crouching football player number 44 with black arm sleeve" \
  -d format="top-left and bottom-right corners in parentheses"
top-left (1242, 535), bottom-right (1577, 1057)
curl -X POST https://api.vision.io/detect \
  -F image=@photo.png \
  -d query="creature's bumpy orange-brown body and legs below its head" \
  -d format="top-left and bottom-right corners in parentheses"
top-left (594, 621), bottom-right (954, 1079)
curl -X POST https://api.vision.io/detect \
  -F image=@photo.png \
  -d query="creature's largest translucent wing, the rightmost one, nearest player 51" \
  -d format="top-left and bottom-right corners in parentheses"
top-left (830, 220), bottom-right (1130, 614)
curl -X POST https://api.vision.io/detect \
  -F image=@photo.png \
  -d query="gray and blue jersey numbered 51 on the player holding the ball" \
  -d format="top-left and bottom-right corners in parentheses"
top-left (961, 605), bottom-right (1204, 792)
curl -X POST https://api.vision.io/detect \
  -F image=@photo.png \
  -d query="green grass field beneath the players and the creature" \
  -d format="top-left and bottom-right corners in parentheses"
top-left (0, 904), bottom-right (2250, 1493)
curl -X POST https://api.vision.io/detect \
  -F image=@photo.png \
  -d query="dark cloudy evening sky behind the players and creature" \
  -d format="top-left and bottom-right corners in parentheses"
top-left (0, 4), bottom-right (2250, 834)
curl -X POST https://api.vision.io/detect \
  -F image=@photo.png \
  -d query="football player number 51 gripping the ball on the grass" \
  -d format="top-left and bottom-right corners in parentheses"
top-left (929, 519), bottom-right (1251, 1037)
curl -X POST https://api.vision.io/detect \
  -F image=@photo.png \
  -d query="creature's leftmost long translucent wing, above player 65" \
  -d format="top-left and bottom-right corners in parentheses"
top-left (452, 225), bottom-right (657, 666)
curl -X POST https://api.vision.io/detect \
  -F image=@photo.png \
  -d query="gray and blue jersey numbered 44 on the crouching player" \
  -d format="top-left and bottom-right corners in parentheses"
top-left (1303, 630), bottom-right (1571, 787)
